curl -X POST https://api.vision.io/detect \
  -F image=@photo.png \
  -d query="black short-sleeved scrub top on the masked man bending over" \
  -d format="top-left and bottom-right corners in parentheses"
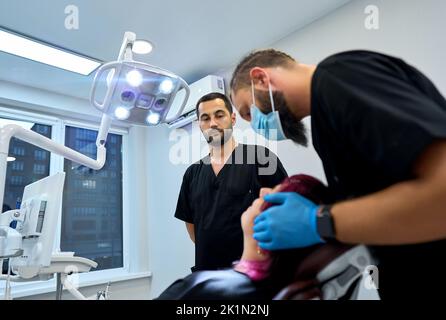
top-left (311, 51), bottom-right (446, 299)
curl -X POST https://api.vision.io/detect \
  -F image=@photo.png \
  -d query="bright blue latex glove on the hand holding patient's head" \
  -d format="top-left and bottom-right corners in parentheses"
top-left (253, 192), bottom-right (324, 250)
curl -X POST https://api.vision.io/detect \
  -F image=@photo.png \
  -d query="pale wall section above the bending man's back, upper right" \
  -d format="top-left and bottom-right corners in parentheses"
top-left (274, 0), bottom-right (446, 93)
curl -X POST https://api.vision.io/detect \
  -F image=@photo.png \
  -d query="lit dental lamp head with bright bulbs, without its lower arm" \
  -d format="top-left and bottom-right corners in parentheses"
top-left (91, 33), bottom-right (190, 126)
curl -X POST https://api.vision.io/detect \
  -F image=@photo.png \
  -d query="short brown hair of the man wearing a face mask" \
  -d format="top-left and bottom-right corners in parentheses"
top-left (230, 49), bottom-right (296, 92)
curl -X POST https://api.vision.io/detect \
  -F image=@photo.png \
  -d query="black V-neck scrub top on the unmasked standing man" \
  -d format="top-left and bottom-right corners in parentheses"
top-left (175, 144), bottom-right (287, 270)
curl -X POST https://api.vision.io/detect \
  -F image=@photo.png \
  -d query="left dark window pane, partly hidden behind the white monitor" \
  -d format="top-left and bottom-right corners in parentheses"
top-left (3, 121), bottom-right (51, 209)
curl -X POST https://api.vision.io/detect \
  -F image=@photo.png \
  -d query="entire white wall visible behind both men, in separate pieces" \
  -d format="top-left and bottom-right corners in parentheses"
top-left (147, 0), bottom-right (446, 297)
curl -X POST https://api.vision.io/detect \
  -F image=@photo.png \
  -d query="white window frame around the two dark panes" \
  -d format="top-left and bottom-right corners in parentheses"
top-left (0, 104), bottom-right (136, 297)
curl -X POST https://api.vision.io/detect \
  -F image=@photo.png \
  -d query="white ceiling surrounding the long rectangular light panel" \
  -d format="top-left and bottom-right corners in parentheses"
top-left (0, 0), bottom-right (350, 98)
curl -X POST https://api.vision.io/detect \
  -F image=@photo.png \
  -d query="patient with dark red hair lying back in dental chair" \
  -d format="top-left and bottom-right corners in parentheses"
top-left (157, 174), bottom-right (336, 300)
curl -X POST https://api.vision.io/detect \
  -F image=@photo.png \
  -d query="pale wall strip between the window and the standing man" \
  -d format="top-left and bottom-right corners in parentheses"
top-left (146, 122), bottom-right (200, 297)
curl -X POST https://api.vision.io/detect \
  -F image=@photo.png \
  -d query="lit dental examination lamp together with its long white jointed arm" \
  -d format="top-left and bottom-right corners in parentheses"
top-left (0, 32), bottom-right (190, 298)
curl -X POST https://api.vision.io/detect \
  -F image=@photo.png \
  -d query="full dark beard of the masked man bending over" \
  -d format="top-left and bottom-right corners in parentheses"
top-left (255, 91), bottom-right (308, 147)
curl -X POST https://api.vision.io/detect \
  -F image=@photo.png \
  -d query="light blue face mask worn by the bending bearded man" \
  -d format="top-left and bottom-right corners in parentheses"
top-left (251, 80), bottom-right (287, 141)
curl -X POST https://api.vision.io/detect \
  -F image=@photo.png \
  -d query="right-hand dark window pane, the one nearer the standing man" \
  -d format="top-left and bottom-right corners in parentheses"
top-left (60, 126), bottom-right (123, 270)
